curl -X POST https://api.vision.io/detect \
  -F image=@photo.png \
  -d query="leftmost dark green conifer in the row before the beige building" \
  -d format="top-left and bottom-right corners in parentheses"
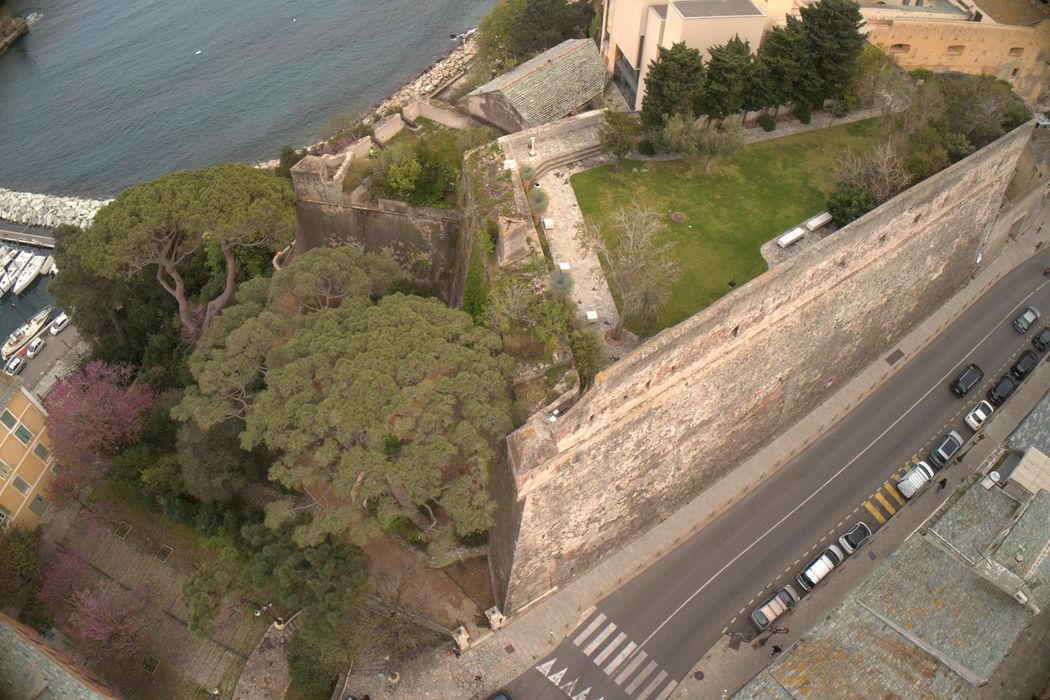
top-left (642, 42), bottom-right (704, 129)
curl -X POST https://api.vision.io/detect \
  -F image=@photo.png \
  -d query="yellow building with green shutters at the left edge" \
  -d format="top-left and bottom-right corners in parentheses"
top-left (0, 374), bottom-right (57, 528)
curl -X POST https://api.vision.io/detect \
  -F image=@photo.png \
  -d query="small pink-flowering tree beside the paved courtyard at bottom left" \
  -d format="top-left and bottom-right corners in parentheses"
top-left (69, 584), bottom-right (149, 660)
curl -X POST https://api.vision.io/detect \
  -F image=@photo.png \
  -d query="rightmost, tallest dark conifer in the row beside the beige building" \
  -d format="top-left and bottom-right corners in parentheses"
top-left (799, 0), bottom-right (866, 106)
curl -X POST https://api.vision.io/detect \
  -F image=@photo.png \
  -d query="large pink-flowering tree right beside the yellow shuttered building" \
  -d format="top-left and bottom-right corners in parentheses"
top-left (45, 362), bottom-right (156, 482)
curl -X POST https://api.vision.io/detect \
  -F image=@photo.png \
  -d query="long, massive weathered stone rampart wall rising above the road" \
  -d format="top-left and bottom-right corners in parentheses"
top-left (490, 121), bottom-right (1031, 611)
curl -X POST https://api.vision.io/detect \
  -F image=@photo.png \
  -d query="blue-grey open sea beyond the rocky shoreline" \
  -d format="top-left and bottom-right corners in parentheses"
top-left (0, 0), bottom-right (495, 197)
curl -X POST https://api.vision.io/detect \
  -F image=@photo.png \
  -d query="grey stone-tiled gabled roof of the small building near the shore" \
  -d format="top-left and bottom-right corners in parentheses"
top-left (470, 39), bottom-right (605, 127)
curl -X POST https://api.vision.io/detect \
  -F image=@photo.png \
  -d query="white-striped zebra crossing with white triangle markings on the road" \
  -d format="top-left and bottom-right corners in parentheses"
top-left (536, 613), bottom-right (678, 700)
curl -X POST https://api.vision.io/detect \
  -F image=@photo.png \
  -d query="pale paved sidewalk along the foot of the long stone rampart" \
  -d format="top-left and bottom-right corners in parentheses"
top-left (349, 193), bottom-right (1047, 700)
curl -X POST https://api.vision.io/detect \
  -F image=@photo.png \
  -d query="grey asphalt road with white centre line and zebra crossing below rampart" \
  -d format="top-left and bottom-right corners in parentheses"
top-left (507, 252), bottom-right (1050, 700)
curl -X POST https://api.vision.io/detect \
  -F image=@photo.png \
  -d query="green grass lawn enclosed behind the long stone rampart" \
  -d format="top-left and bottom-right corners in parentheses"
top-left (571, 120), bottom-right (881, 336)
